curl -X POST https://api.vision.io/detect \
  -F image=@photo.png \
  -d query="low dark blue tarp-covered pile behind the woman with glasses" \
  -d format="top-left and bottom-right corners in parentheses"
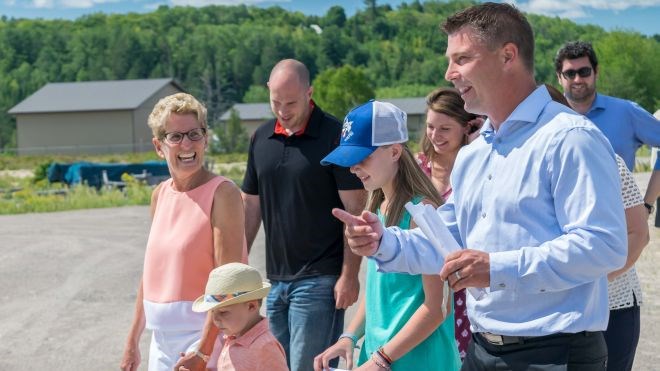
top-left (47, 161), bottom-right (170, 188)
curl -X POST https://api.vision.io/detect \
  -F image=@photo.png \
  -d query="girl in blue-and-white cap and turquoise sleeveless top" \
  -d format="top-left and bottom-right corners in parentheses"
top-left (314, 100), bottom-right (460, 371)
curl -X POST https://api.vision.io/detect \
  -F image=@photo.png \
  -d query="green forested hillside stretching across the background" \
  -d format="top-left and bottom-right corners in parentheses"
top-left (0, 0), bottom-right (660, 149)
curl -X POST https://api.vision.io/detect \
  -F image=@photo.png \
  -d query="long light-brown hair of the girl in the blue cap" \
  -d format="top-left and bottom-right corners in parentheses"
top-left (367, 143), bottom-right (442, 227)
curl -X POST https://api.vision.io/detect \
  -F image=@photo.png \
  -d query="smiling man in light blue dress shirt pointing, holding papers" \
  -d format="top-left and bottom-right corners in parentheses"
top-left (333, 3), bottom-right (627, 370)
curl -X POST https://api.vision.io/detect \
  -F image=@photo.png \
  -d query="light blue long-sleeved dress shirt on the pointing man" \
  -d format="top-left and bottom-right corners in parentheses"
top-left (372, 86), bottom-right (627, 336)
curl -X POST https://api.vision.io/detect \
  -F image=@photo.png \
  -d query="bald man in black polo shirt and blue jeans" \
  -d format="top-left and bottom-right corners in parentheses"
top-left (242, 59), bottom-right (366, 371)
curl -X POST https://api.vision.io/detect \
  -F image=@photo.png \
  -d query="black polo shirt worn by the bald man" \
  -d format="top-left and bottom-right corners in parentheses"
top-left (242, 106), bottom-right (363, 281)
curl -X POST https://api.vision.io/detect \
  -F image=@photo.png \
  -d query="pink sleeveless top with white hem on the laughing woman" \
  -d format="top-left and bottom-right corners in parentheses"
top-left (142, 176), bottom-right (247, 329)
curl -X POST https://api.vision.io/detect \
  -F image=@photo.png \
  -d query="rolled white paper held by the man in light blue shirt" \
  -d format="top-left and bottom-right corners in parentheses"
top-left (405, 202), bottom-right (486, 300)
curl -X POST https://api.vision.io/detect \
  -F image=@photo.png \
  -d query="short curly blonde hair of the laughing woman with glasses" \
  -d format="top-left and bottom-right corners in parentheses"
top-left (147, 93), bottom-right (206, 139)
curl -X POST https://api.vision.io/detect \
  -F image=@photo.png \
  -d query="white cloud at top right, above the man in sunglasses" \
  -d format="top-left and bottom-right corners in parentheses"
top-left (507, 0), bottom-right (660, 19)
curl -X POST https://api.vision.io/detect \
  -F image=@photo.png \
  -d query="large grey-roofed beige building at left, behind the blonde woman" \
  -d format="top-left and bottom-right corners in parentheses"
top-left (9, 78), bottom-right (183, 155)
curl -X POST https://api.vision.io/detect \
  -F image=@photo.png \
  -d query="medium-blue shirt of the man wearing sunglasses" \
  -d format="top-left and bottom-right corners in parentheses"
top-left (586, 94), bottom-right (660, 171)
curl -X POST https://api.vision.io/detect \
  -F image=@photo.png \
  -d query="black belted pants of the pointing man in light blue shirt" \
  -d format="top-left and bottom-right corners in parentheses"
top-left (461, 332), bottom-right (607, 371)
